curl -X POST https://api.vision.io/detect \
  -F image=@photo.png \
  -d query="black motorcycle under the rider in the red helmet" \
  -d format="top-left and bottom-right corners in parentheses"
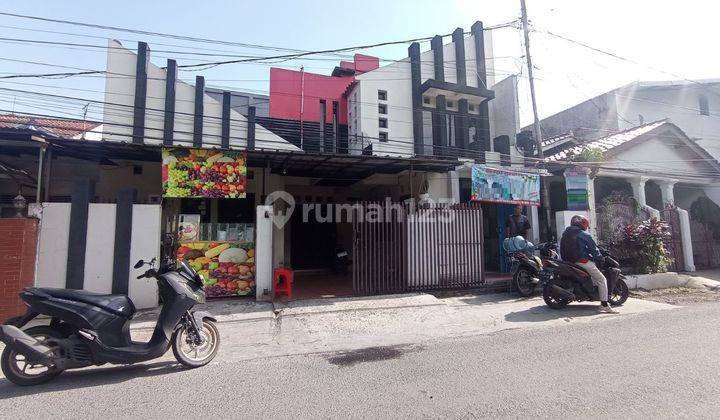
top-left (540, 247), bottom-right (630, 309)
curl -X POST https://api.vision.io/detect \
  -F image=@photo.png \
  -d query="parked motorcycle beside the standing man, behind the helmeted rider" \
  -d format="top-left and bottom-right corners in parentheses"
top-left (506, 241), bottom-right (557, 297)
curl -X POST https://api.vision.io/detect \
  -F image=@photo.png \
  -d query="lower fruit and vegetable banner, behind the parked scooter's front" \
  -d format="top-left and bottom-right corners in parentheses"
top-left (177, 241), bottom-right (255, 297)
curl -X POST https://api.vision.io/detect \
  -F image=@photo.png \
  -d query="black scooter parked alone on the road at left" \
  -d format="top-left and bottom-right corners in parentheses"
top-left (0, 258), bottom-right (220, 385)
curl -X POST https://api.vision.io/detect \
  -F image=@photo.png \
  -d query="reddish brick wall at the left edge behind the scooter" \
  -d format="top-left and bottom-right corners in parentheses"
top-left (0, 218), bottom-right (38, 322)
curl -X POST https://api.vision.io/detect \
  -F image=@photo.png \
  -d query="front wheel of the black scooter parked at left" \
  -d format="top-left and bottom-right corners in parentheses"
top-left (172, 319), bottom-right (220, 368)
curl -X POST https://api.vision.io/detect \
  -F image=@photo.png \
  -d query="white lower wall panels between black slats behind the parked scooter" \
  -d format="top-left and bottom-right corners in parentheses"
top-left (35, 203), bottom-right (161, 309)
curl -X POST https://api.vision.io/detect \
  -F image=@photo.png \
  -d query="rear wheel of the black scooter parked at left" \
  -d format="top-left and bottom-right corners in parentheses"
top-left (0, 325), bottom-right (64, 386)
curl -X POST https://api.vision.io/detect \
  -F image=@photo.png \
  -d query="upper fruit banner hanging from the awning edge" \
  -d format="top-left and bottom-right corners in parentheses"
top-left (162, 148), bottom-right (247, 198)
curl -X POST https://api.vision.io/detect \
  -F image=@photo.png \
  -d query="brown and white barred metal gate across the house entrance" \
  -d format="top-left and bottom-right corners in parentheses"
top-left (353, 202), bottom-right (484, 294)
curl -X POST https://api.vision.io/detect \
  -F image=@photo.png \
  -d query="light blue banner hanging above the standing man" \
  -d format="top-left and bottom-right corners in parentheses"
top-left (470, 165), bottom-right (540, 206)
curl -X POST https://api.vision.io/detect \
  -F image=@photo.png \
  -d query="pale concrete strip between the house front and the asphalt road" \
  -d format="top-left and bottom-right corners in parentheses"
top-left (132, 294), bottom-right (674, 360)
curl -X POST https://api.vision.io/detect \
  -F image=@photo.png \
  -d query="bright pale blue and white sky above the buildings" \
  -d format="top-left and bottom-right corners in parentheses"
top-left (0, 0), bottom-right (720, 126)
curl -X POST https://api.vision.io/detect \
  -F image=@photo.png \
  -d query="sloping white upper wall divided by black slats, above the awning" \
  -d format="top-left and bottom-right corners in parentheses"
top-left (103, 40), bottom-right (300, 151)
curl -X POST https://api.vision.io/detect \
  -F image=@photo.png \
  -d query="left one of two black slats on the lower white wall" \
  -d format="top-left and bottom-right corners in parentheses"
top-left (65, 178), bottom-right (94, 289)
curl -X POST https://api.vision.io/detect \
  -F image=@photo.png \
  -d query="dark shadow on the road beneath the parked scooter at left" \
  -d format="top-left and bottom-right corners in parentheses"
top-left (0, 361), bottom-right (187, 400)
